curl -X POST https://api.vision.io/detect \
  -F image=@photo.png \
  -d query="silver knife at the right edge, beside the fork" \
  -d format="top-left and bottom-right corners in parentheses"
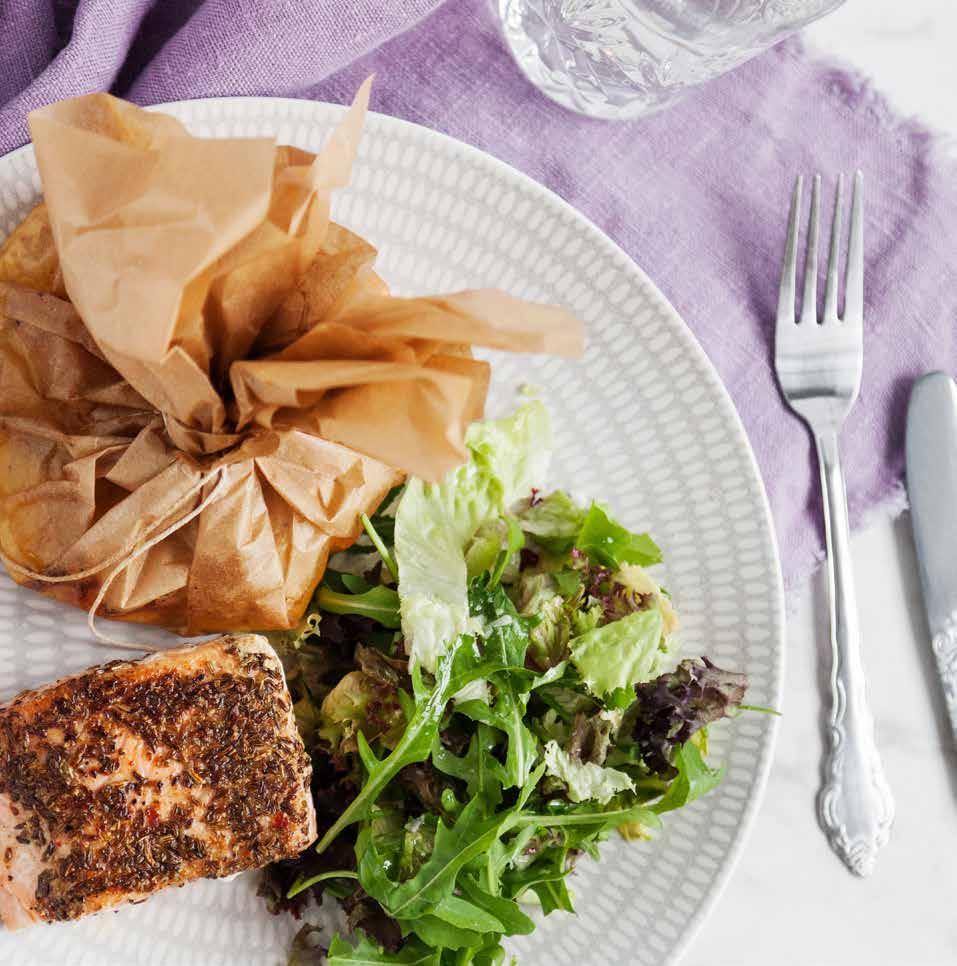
top-left (907, 372), bottom-right (957, 737)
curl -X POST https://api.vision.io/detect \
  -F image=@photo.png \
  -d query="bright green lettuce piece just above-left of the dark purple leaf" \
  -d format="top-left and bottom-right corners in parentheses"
top-left (568, 607), bottom-right (665, 703)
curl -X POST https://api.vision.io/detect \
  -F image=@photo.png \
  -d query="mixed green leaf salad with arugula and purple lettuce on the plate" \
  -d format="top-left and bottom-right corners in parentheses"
top-left (261, 402), bottom-right (746, 966)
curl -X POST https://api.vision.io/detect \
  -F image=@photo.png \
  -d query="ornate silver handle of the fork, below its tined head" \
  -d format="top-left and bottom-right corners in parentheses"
top-left (815, 431), bottom-right (894, 876)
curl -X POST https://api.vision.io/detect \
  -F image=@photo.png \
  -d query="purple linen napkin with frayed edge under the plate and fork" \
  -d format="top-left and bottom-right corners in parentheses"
top-left (0, 0), bottom-right (957, 583)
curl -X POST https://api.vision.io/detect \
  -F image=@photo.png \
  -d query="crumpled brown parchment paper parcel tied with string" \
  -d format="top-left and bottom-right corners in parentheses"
top-left (0, 82), bottom-right (582, 633)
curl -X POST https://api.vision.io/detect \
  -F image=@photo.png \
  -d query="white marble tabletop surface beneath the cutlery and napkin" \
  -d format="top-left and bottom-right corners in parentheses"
top-left (685, 0), bottom-right (957, 966)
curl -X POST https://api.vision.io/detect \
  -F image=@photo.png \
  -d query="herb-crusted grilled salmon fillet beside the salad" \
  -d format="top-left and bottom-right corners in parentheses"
top-left (0, 634), bottom-right (316, 929)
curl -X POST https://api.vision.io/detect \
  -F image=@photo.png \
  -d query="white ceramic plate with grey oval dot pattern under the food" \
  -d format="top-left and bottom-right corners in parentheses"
top-left (0, 98), bottom-right (784, 966)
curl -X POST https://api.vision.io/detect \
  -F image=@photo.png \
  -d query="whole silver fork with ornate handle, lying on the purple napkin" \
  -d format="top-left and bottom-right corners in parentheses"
top-left (774, 171), bottom-right (894, 875)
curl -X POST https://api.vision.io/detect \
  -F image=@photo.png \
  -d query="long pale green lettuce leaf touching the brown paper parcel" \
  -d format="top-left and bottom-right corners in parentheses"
top-left (395, 402), bottom-right (552, 672)
